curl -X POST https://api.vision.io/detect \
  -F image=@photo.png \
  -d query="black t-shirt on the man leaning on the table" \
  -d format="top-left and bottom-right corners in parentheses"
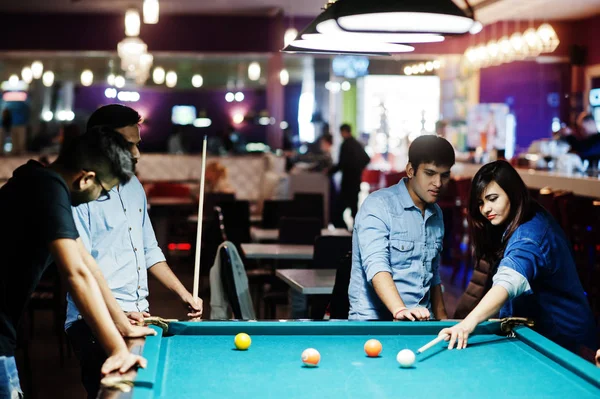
top-left (0, 161), bottom-right (79, 356)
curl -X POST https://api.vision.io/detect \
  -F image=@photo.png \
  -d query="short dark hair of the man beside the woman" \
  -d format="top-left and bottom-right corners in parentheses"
top-left (408, 134), bottom-right (455, 173)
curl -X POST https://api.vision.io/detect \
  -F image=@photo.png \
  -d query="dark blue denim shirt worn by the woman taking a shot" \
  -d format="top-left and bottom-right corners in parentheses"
top-left (494, 209), bottom-right (596, 352)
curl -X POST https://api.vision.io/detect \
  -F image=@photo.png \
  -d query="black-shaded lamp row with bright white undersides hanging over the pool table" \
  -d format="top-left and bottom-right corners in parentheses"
top-left (283, 0), bottom-right (481, 55)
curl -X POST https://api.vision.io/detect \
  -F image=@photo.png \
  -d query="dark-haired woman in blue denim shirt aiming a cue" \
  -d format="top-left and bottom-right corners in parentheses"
top-left (440, 161), bottom-right (596, 353)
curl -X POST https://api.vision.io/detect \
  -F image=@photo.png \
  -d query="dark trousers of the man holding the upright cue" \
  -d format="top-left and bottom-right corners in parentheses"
top-left (67, 320), bottom-right (107, 399)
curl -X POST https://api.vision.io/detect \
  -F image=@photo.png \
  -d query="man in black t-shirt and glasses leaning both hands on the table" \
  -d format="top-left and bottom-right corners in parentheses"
top-left (0, 129), bottom-right (154, 399)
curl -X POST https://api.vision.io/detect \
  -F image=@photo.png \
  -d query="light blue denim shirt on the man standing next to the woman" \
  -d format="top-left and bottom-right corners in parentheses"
top-left (348, 178), bottom-right (444, 320)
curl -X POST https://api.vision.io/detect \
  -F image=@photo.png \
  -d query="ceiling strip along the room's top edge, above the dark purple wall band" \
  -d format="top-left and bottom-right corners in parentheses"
top-left (0, 0), bottom-right (600, 24)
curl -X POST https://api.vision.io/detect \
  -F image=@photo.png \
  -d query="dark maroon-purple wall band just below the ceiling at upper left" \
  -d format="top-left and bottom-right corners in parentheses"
top-left (0, 13), bottom-right (285, 53)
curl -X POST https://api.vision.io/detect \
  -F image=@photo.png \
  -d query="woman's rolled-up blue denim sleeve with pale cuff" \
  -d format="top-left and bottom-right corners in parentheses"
top-left (493, 238), bottom-right (545, 299)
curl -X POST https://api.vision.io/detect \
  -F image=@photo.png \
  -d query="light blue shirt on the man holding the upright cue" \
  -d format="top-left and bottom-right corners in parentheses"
top-left (65, 176), bottom-right (165, 329)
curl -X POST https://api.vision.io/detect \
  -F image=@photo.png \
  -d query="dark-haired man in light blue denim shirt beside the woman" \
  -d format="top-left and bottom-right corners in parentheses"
top-left (348, 135), bottom-right (454, 320)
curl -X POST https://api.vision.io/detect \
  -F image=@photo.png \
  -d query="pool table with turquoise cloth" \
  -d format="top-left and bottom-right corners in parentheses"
top-left (105, 321), bottom-right (600, 399)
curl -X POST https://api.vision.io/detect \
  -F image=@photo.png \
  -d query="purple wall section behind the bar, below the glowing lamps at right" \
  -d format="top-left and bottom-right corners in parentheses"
top-left (480, 62), bottom-right (570, 149)
